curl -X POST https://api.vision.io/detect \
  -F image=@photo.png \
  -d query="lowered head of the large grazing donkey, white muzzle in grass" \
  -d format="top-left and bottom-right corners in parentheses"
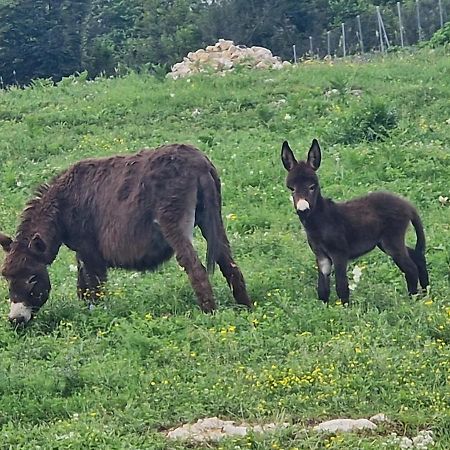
top-left (0, 234), bottom-right (51, 324)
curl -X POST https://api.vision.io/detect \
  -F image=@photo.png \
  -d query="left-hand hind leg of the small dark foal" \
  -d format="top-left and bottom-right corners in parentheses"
top-left (379, 236), bottom-right (419, 295)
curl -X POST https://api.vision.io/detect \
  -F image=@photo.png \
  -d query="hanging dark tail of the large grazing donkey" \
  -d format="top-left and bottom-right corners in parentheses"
top-left (195, 170), bottom-right (227, 272)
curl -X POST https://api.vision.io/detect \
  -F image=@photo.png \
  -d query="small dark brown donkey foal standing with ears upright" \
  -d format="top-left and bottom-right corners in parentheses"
top-left (281, 139), bottom-right (428, 303)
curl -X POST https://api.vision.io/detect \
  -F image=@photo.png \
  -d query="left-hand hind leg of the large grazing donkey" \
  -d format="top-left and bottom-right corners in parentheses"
top-left (159, 216), bottom-right (216, 312)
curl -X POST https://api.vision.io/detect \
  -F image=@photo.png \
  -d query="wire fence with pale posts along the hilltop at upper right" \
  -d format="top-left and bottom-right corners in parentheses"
top-left (292, 0), bottom-right (450, 61)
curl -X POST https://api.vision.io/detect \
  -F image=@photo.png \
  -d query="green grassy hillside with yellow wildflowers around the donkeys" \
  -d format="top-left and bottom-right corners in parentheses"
top-left (0, 52), bottom-right (450, 450)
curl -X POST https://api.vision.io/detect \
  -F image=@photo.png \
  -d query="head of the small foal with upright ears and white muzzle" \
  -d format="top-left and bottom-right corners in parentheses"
top-left (281, 139), bottom-right (321, 218)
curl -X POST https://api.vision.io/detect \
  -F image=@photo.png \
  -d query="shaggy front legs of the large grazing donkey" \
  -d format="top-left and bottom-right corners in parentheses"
top-left (77, 253), bottom-right (106, 303)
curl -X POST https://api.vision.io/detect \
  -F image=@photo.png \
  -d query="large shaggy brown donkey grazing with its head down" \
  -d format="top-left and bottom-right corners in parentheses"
top-left (0, 144), bottom-right (251, 323)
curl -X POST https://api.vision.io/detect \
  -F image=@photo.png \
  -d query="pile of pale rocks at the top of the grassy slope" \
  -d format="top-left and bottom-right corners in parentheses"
top-left (167, 39), bottom-right (291, 79)
